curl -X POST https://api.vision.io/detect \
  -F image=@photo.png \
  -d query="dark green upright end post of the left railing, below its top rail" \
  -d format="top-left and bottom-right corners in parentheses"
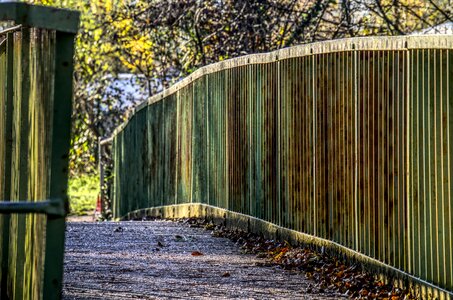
top-left (43, 32), bottom-right (74, 300)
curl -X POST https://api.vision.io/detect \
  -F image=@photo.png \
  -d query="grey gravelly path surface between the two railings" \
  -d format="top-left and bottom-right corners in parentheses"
top-left (63, 221), bottom-right (336, 300)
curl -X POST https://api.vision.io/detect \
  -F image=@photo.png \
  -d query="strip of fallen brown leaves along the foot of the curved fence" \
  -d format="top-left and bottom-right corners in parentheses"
top-left (179, 218), bottom-right (416, 300)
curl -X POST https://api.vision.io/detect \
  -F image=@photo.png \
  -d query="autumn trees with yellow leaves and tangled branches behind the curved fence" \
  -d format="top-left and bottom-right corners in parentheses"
top-left (29, 0), bottom-right (453, 174)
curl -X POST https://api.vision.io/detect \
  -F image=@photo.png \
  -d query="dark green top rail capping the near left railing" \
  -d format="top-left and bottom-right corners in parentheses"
top-left (0, 2), bottom-right (80, 33)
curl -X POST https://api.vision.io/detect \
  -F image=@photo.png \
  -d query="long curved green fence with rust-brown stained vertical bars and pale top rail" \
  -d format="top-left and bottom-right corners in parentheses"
top-left (107, 36), bottom-right (453, 297)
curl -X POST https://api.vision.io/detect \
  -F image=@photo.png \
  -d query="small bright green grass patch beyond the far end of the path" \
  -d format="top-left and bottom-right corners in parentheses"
top-left (68, 175), bottom-right (99, 216)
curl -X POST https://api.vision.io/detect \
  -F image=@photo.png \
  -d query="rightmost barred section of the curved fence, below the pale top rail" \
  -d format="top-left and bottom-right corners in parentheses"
top-left (407, 50), bottom-right (453, 289)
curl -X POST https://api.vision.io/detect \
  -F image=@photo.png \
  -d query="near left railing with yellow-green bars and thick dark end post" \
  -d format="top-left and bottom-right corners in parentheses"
top-left (0, 2), bottom-right (79, 300)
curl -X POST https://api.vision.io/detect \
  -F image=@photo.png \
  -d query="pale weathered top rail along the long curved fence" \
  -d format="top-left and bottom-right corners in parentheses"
top-left (107, 35), bottom-right (453, 144)
